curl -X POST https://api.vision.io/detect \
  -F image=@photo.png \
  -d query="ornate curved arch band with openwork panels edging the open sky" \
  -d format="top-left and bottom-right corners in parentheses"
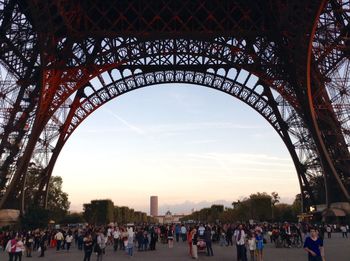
top-left (33, 68), bottom-right (314, 209)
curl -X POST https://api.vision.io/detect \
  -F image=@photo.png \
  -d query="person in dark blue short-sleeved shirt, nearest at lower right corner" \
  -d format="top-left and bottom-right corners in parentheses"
top-left (304, 228), bottom-right (324, 261)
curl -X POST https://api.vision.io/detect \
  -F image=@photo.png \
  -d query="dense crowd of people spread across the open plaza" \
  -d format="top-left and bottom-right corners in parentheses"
top-left (0, 222), bottom-right (349, 261)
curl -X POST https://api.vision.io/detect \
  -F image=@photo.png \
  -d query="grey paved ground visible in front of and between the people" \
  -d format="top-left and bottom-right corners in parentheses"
top-left (0, 235), bottom-right (350, 261)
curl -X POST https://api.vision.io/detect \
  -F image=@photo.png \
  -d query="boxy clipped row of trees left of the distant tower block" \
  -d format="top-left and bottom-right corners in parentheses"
top-left (83, 199), bottom-right (154, 225)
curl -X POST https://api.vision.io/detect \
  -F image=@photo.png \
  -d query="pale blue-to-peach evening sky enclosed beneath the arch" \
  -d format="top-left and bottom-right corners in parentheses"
top-left (53, 84), bottom-right (299, 214)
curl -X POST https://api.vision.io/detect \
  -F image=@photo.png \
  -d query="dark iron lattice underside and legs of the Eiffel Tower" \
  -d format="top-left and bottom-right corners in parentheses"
top-left (0, 0), bottom-right (350, 210)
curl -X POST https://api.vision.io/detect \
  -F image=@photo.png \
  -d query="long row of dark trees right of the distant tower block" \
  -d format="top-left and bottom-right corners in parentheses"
top-left (182, 192), bottom-right (301, 223)
